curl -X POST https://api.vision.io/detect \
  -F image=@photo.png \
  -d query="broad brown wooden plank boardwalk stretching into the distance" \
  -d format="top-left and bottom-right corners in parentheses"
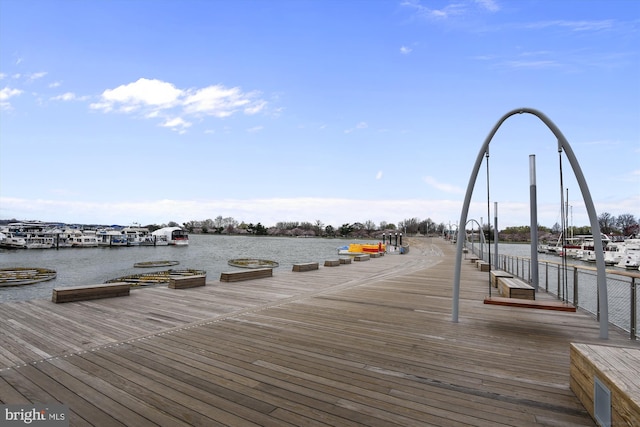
top-left (0, 238), bottom-right (640, 427)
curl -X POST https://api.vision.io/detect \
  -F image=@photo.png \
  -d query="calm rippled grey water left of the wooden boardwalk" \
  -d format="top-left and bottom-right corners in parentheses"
top-left (0, 234), bottom-right (364, 303)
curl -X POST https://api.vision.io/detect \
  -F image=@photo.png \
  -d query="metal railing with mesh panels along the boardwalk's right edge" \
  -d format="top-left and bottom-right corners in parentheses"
top-left (472, 247), bottom-right (640, 340)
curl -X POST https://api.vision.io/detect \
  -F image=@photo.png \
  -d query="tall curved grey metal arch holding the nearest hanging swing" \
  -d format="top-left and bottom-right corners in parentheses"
top-left (451, 108), bottom-right (609, 339)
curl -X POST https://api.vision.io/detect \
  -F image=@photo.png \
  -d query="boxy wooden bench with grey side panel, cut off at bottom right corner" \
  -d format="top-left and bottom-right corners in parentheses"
top-left (569, 343), bottom-right (640, 426)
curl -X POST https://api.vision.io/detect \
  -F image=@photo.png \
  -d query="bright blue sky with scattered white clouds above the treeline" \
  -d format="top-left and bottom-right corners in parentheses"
top-left (0, 0), bottom-right (640, 228)
